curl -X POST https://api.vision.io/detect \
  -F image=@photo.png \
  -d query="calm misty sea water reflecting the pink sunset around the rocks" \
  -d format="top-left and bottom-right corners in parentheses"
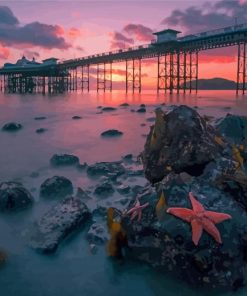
top-left (0, 92), bottom-right (247, 296)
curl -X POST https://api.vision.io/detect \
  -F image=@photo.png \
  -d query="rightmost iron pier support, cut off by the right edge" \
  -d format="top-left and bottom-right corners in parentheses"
top-left (236, 42), bottom-right (247, 95)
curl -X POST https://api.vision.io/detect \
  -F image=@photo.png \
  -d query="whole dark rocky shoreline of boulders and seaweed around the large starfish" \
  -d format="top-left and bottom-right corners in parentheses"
top-left (0, 106), bottom-right (247, 290)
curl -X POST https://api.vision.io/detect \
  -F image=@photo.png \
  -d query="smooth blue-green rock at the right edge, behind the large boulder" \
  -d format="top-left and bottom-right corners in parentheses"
top-left (216, 115), bottom-right (247, 146)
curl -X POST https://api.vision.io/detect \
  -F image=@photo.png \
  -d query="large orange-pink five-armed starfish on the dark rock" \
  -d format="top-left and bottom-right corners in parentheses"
top-left (167, 192), bottom-right (232, 246)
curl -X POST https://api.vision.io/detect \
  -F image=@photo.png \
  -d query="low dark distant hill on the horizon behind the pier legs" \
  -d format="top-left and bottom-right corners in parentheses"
top-left (183, 77), bottom-right (237, 90)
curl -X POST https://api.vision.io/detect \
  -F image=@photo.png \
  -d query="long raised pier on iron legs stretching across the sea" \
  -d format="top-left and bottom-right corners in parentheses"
top-left (0, 24), bottom-right (247, 94)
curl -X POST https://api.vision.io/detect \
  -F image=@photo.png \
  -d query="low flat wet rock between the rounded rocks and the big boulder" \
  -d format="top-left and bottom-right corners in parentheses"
top-left (87, 161), bottom-right (125, 179)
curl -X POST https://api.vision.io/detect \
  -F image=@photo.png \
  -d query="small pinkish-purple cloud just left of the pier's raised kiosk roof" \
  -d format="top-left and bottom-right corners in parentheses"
top-left (123, 24), bottom-right (153, 42)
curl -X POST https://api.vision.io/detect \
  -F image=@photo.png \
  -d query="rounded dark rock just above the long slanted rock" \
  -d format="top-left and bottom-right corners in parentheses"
top-left (40, 176), bottom-right (73, 198)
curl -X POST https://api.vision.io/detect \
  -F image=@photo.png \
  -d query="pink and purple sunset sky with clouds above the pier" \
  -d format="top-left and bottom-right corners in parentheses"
top-left (0, 0), bottom-right (247, 86)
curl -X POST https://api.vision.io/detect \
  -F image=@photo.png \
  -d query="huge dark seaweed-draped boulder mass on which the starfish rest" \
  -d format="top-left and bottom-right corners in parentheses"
top-left (121, 106), bottom-right (247, 290)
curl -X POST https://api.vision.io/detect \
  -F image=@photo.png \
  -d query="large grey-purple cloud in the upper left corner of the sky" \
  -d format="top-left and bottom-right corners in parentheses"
top-left (0, 6), bottom-right (71, 49)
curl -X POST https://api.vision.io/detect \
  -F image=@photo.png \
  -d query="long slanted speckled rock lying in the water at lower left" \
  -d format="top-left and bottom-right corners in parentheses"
top-left (30, 197), bottom-right (91, 253)
